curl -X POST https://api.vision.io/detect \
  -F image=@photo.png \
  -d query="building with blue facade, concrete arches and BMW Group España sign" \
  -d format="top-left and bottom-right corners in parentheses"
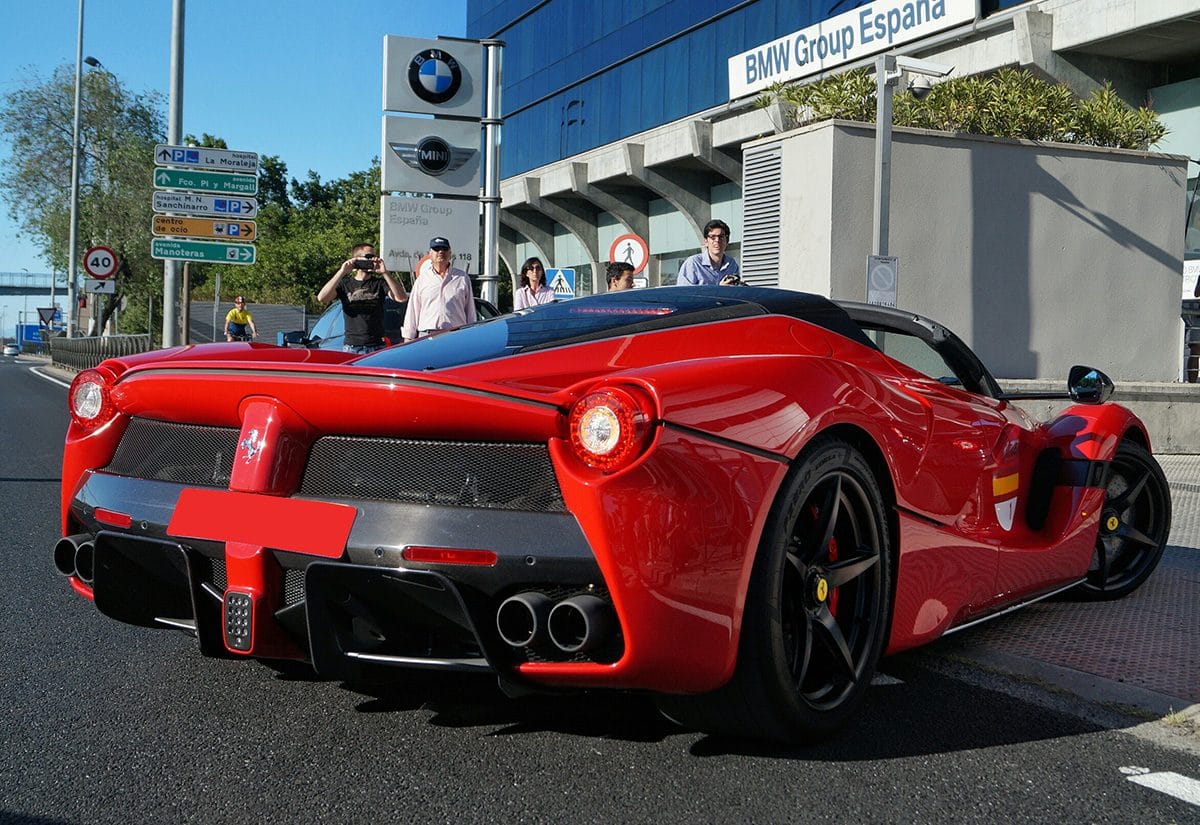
top-left (467, 0), bottom-right (1200, 294)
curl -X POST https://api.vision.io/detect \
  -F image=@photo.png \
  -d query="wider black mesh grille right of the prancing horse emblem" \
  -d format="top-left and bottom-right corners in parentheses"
top-left (300, 435), bottom-right (566, 512)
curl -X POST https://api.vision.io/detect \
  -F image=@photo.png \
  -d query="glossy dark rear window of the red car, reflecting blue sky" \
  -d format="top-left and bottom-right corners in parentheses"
top-left (356, 287), bottom-right (862, 369)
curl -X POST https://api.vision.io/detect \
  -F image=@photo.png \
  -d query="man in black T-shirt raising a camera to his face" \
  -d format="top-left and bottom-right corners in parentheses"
top-left (317, 243), bottom-right (408, 355)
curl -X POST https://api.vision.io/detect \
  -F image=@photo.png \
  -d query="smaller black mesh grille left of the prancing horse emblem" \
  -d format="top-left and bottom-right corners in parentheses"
top-left (104, 418), bottom-right (238, 487)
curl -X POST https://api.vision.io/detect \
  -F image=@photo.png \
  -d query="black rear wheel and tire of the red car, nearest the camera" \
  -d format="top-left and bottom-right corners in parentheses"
top-left (659, 438), bottom-right (892, 742)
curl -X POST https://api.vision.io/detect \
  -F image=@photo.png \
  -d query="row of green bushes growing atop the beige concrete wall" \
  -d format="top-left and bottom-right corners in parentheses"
top-left (757, 68), bottom-right (1166, 150)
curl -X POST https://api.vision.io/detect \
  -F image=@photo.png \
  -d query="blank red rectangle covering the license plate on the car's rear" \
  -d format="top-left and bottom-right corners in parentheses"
top-left (167, 489), bottom-right (358, 559)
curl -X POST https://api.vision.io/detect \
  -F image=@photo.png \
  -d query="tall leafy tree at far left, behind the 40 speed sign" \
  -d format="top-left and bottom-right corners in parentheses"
top-left (0, 65), bottom-right (164, 333)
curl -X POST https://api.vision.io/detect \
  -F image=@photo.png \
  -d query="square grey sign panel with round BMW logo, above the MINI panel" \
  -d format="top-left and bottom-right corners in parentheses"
top-left (383, 35), bottom-right (486, 118)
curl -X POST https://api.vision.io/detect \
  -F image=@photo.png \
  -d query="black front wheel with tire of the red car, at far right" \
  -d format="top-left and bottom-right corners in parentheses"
top-left (1075, 441), bottom-right (1171, 601)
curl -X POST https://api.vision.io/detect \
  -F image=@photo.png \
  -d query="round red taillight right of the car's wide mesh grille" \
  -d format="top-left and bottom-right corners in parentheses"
top-left (569, 387), bottom-right (654, 472)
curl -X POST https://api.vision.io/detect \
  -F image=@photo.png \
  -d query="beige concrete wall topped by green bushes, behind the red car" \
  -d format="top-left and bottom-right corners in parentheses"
top-left (745, 121), bottom-right (1186, 381)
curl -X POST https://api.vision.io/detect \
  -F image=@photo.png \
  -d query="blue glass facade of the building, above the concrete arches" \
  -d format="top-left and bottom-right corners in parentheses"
top-left (467, 0), bottom-right (864, 177)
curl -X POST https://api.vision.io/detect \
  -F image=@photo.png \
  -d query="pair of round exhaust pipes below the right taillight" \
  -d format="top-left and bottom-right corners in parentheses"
top-left (496, 591), bottom-right (616, 654)
